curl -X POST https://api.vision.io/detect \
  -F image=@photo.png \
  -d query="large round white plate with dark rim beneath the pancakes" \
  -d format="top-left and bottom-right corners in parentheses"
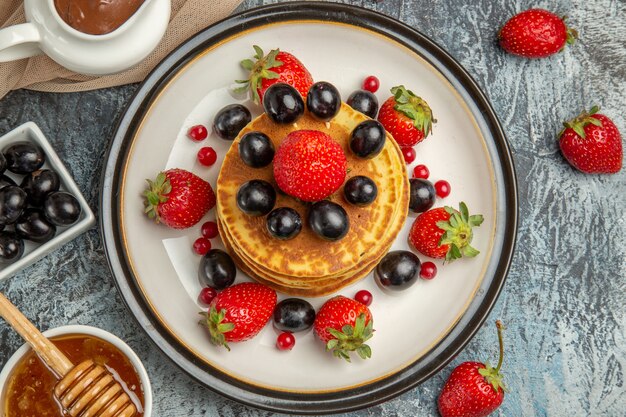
top-left (101, 2), bottom-right (517, 413)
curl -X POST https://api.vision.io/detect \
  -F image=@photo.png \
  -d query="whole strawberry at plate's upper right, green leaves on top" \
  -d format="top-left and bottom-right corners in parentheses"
top-left (378, 85), bottom-right (436, 148)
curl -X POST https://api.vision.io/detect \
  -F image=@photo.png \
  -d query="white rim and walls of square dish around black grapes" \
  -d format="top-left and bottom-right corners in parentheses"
top-left (0, 122), bottom-right (96, 281)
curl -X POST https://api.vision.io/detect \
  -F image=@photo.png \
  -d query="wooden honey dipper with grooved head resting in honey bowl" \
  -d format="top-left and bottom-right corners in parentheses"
top-left (0, 293), bottom-right (137, 417)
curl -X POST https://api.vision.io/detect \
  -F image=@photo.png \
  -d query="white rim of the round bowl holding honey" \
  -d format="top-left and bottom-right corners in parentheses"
top-left (0, 325), bottom-right (152, 417)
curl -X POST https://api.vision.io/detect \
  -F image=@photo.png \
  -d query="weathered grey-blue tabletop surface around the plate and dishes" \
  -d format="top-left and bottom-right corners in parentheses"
top-left (0, 0), bottom-right (626, 417)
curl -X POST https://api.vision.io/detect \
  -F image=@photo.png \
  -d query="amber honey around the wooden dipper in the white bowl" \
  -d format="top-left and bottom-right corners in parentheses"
top-left (2, 334), bottom-right (144, 417)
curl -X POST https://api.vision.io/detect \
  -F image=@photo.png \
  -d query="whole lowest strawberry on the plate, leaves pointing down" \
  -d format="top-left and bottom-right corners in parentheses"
top-left (313, 295), bottom-right (374, 362)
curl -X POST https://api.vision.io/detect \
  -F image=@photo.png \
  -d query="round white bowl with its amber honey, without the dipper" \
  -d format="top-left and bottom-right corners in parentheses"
top-left (0, 325), bottom-right (152, 417)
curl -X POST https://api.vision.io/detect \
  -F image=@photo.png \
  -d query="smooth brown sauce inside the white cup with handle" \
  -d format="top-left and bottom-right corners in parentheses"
top-left (54, 0), bottom-right (144, 35)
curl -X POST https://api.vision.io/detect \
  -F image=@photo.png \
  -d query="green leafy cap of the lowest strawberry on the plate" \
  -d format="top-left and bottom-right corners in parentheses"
top-left (326, 313), bottom-right (374, 362)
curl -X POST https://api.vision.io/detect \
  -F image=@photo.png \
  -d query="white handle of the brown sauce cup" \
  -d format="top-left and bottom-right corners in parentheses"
top-left (0, 23), bottom-right (41, 62)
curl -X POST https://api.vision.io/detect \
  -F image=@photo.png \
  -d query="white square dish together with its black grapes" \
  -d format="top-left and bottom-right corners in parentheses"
top-left (0, 122), bottom-right (95, 279)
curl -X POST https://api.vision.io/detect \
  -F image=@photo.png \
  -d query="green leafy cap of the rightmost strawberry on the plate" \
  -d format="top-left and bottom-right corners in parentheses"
top-left (436, 202), bottom-right (484, 262)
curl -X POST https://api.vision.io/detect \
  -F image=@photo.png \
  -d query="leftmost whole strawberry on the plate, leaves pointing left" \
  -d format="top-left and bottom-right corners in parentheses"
top-left (143, 168), bottom-right (215, 229)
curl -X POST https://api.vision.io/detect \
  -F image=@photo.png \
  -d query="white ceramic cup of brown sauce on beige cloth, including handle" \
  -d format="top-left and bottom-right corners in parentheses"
top-left (0, 0), bottom-right (171, 75)
